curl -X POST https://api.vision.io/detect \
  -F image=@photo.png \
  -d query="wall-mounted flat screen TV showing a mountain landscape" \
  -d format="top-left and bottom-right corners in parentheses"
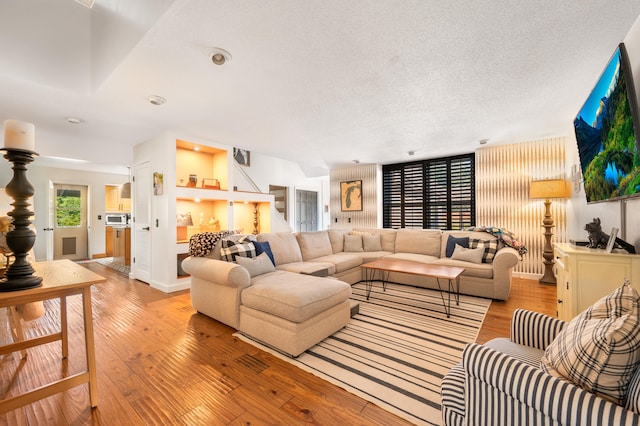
top-left (573, 43), bottom-right (640, 203)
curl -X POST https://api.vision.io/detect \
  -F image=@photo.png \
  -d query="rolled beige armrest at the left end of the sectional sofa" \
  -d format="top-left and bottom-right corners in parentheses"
top-left (182, 256), bottom-right (251, 289)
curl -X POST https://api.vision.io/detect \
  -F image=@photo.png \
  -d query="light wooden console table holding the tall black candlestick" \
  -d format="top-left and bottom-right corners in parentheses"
top-left (0, 260), bottom-right (106, 414)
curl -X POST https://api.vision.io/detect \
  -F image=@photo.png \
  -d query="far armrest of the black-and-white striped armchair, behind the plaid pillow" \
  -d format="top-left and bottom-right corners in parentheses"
top-left (511, 309), bottom-right (566, 350)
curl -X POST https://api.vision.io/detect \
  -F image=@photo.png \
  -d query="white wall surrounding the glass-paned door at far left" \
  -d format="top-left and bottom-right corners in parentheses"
top-left (0, 157), bottom-right (129, 261)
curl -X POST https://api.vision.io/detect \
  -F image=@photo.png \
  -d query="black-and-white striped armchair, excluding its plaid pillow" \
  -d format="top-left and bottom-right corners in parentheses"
top-left (441, 309), bottom-right (640, 426)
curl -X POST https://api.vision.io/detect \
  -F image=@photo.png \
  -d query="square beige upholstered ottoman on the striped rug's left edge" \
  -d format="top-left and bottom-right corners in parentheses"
top-left (239, 271), bottom-right (351, 357)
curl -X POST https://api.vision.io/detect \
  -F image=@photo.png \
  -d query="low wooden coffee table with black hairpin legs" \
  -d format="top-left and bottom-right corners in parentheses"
top-left (362, 258), bottom-right (464, 318)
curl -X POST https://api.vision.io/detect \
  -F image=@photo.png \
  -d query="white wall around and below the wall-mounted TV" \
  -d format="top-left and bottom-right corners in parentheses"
top-left (567, 17), bottom-right (640, 253)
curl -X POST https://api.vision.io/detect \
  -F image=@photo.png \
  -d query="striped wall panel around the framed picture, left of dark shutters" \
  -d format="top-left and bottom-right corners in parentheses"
top-left (329, 164), bottom-right (382, 228)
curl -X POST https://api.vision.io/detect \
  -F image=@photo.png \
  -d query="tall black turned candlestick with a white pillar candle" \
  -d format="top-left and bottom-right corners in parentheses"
top-left (0, 120), bottom-right (42, 291)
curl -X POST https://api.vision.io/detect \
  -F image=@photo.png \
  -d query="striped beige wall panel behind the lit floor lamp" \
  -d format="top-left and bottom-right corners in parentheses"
top-left (476, 138), bottom-right (567, 275)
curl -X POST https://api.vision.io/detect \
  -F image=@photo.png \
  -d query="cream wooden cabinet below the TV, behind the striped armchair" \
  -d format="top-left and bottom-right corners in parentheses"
top-left (554, 243), bottom-right (640, 321)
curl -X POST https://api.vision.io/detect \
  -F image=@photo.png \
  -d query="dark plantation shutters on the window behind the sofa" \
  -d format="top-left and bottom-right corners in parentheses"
top-left (382, 154), bottom-right (475, 229)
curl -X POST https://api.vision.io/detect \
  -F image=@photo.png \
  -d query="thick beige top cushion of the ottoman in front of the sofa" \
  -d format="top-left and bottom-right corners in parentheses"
top-left (241, 271), bottom-right (351, 323)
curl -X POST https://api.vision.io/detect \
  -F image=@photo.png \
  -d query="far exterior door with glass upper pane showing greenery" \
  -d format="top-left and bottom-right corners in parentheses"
top-left (53, 184), bottom-right (89, 260)
